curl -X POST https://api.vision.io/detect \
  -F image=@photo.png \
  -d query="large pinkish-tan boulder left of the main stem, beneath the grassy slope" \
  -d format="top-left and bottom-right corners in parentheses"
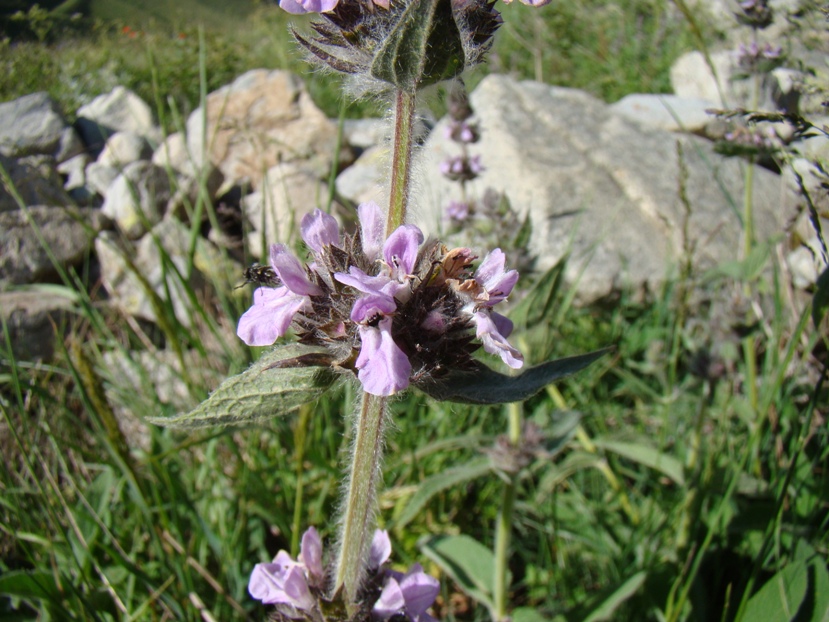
top-left (187, 69), bottom-right (344, 189)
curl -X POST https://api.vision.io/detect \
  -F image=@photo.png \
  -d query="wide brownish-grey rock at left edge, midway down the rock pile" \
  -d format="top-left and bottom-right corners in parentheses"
top-left (0, 206), bottom-right (110, 285)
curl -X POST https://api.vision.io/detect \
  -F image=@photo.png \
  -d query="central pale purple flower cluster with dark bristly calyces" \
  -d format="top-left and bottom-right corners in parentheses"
top-left (237, 203), bottom-right (523, 396)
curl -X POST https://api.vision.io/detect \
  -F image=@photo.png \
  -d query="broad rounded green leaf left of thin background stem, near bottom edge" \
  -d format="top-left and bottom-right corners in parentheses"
top-left (420, 535), bottom-right (498, 609)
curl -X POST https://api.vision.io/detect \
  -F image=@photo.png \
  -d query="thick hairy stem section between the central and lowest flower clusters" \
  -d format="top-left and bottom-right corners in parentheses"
top-left (334, 393), bottom-right (386, 603)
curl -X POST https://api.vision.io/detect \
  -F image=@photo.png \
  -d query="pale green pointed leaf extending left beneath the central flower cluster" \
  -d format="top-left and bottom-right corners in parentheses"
top-left (150, 343), bottom-right (337, 428)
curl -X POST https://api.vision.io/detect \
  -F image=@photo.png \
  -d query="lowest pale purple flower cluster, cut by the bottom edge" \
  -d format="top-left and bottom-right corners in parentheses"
top-left (248, 527), bottom-right (440, 622)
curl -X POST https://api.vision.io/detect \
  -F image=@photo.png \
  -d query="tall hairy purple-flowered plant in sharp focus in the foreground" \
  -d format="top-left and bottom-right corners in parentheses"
top-left (155, 0), bottom-right (604, 622)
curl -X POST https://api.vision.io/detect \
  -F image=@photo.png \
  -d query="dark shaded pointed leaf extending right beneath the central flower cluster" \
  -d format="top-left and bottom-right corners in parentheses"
top-left (417, 348), bottom-right (611, 404)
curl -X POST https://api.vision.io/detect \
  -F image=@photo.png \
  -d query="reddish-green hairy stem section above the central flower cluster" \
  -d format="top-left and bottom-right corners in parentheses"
top-left (386, 91), bottom-right (415, 235)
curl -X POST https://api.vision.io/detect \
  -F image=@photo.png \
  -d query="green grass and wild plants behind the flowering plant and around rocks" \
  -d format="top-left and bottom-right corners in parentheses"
top-left (0, 0), bottom-right (829, 622)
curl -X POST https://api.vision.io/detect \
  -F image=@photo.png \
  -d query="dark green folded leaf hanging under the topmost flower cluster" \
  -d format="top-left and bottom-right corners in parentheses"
top-left (371, 0), bottom-right (464, 93)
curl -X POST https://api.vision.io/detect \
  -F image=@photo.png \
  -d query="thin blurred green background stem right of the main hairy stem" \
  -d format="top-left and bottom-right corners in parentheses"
top-left (492, 404), bottom-right (523, 622)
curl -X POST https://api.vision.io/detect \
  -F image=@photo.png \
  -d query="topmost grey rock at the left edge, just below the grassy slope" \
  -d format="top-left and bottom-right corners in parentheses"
top-left (0, 93), bottom-right (67, 157)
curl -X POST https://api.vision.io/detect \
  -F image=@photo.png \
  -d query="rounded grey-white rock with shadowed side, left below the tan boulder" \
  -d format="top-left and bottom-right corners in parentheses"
top-left (101, 161), bottom-right (173, 239)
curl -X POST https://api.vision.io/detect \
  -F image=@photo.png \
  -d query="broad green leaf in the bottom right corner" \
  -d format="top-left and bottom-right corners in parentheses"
top-left (743, 561), bottom-right (812, 622)
